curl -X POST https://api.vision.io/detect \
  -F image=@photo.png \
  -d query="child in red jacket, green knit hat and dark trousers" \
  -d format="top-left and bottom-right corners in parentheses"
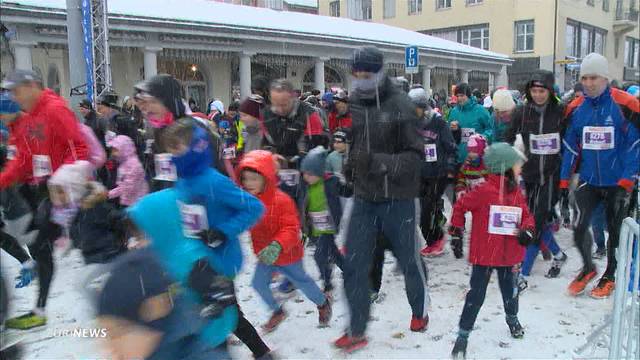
top-left (449, 143), bottom-right (535, 358)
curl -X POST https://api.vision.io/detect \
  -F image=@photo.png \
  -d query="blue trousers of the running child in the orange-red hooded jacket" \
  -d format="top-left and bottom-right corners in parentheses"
top-left (251, 260), bottom-right (327, 311)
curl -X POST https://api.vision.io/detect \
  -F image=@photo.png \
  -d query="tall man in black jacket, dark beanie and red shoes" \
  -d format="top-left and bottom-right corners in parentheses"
top-left (335, 47), bottom-right (428, 352)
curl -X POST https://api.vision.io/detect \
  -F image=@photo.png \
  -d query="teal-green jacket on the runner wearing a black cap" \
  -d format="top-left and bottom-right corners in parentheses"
top-left (448, 96), bottom-right (493, 164)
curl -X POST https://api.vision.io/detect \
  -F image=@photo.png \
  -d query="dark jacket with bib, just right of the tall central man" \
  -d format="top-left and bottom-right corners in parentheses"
top-left (418, 112), bottom-right (458, 179)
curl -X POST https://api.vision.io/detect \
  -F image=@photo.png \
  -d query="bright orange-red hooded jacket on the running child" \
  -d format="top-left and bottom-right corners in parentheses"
top-left (237, 150), bottom-right (303, 266)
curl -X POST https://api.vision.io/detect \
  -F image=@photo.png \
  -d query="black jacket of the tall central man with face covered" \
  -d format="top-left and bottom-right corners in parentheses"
top-left (345, 78), bottom-right (424, 202)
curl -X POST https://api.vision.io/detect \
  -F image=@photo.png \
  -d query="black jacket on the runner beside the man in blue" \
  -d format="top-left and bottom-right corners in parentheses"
top-left (505, 102), bottom-right (565, 184)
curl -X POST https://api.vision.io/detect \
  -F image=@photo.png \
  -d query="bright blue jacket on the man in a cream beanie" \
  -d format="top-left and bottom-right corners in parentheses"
top-left (560, 88), bottom-right (640, 186)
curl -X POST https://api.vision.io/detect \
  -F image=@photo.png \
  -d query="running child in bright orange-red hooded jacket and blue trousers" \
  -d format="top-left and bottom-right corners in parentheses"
top-left (238, 150), bottom-right (331, 332)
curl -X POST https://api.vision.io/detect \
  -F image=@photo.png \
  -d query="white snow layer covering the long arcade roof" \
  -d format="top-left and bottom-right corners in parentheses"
top-left (3, 0), bottom-right (509, 60)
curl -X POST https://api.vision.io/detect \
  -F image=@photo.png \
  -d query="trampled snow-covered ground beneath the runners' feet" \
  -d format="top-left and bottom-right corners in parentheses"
top-left (0, 225), bottom-right (612, 359)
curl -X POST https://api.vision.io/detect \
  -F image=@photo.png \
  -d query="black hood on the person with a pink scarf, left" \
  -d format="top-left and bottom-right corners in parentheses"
top-left (134, 74), bottom-right (185, 119)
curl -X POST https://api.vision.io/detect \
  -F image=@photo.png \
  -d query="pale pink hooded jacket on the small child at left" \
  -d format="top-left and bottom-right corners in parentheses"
top-left (109, 135), bottom-right (149, 206)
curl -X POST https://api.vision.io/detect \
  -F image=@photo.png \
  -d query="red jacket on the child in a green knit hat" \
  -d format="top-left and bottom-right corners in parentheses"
top-left (451, 174), bottom-right (535, 266)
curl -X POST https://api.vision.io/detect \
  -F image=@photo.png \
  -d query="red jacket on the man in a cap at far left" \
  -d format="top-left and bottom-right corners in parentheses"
top-left (0, 89), bottom-right (89, 189)
